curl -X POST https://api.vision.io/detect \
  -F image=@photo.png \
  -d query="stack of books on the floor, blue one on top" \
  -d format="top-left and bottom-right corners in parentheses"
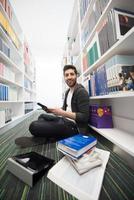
top-left (57, 134), bottom-right (102, 175)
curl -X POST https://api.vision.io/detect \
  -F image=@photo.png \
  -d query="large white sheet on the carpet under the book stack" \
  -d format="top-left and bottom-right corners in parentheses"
top-left (47, 148), bottom-right (110, 200)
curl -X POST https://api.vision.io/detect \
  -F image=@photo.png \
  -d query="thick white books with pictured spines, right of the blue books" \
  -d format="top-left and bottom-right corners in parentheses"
top-left (105, 55), bottom-right (134, 93)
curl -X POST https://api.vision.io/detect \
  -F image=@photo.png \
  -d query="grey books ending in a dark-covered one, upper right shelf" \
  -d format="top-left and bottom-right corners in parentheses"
top-left (98, 9), bottom-right (134, 55)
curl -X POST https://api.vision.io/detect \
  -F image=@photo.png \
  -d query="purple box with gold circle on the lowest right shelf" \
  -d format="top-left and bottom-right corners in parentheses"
top-left (89, 104), bottom-right (113, 128)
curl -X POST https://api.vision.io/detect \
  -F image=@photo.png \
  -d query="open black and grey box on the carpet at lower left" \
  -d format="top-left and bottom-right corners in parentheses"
top-left (7, 152), bottom-right (54, 187)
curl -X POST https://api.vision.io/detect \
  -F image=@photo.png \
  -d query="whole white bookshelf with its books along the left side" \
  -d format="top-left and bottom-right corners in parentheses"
top-left (0, 0), bottom-right (36, 129)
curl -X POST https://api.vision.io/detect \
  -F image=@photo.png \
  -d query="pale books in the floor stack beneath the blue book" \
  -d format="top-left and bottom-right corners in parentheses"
top-left (66, 147), bottom-right (102, 175)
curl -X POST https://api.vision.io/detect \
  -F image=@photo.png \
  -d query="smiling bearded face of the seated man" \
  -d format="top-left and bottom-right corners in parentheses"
top-left (64, 69), bottom-right (77, 87)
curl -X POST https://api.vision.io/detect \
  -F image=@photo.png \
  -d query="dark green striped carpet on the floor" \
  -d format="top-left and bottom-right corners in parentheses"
top-left (0, 113), bottom-right (134, 200)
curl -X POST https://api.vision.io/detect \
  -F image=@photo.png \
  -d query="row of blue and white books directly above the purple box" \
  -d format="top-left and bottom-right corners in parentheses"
top-left (88, 55), bottom-right (134, 96)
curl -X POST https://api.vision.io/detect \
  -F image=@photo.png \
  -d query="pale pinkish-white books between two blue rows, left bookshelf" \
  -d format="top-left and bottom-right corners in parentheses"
top-left (0, 62), bottom-right (15, 82)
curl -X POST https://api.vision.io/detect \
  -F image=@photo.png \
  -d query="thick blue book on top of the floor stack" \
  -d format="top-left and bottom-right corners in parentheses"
top-left (57, 134), bottom-right (97, 158)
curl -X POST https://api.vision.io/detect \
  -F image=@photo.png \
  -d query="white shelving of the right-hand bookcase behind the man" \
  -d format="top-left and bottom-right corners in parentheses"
top-left (62, 0), bottom-right (134, 156)
